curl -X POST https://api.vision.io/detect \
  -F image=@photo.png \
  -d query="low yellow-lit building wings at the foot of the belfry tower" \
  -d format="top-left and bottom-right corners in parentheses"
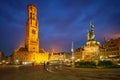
top-left (13, 49), bottom-right (48, 64)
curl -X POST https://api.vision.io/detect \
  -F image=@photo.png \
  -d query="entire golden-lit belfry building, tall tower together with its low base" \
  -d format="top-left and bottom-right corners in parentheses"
top-left (13, 4), bottom-right (48, 64)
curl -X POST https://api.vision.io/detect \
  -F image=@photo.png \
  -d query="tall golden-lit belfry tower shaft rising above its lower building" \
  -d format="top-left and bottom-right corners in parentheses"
top-left (25, 4), bottom-right (39, 52)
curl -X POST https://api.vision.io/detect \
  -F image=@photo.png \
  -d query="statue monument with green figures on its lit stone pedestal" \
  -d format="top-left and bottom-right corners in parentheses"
top-left (82, 22), bottom-right (101, 61)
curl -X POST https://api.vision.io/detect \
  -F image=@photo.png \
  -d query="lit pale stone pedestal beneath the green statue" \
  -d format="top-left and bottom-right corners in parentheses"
top-left (82, 41), bottom-right (100, 61)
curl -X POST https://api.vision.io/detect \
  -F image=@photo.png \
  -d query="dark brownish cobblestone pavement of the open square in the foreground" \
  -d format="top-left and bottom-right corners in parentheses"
top-left (0, 65), bottom-right (120, 80)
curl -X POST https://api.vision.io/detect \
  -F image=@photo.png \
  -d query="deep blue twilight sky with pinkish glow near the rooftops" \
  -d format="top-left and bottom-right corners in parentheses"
top-left (0, 0), bottom-right (120, 55)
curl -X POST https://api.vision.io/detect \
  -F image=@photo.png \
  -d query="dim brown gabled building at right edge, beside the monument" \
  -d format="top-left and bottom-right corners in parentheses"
top-left (101, 37), bottom-right (120, 62)
